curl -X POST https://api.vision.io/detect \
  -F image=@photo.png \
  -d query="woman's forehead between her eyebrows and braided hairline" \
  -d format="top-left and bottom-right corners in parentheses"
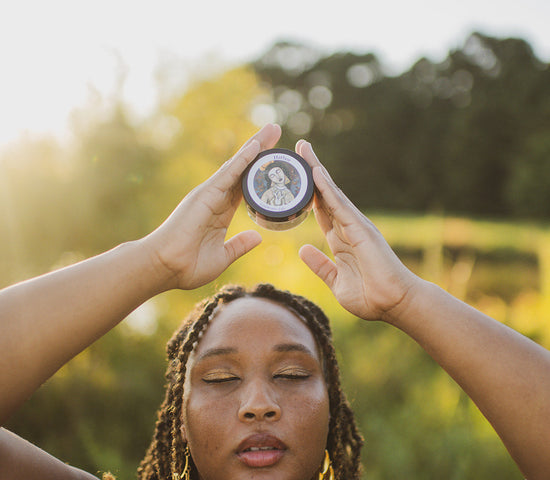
top-left (195, 297), bottom-right (319, 357)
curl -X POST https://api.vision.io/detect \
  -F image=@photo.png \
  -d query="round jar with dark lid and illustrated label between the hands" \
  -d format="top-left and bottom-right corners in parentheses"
top-left (242, 148), bottom-right (314, 230)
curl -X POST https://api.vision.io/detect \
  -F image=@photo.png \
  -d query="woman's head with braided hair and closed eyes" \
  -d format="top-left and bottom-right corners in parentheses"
top-left (139, 285), bottom-right (362, 480)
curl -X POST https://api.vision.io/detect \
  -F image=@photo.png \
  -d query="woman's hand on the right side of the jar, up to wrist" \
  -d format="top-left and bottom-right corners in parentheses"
top-left (296, 140), bottom-right (420, 322)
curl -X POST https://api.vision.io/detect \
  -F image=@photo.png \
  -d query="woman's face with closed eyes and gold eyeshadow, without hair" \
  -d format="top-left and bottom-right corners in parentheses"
top-left (182, 298), bottom-right (329, 480)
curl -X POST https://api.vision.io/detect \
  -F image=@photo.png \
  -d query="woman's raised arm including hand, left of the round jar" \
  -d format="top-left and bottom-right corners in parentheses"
top-left (0, 125), bottom-right (280, 423)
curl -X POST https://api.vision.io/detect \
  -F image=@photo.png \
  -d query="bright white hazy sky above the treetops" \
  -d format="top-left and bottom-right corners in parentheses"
top-left (0, 0), bottom-right (550, 147)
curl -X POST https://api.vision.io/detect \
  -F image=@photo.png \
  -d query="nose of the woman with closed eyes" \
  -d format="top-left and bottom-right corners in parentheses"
top-left (239, 381), bottom-right (281, 422)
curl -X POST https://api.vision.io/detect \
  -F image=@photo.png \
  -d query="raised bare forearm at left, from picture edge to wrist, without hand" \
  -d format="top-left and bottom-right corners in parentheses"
top-left (0, 238), bottom-right (172, 422)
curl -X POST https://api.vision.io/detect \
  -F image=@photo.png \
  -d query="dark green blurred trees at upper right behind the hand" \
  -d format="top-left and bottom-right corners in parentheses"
top-left (254, 33), bottom-right (550, 218)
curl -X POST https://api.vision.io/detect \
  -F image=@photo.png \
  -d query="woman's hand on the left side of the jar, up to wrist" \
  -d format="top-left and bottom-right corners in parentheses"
top-left (143, 124), bottom-right (281, 289)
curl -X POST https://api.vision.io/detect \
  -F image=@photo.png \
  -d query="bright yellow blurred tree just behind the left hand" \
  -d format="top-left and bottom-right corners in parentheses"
top-left (153, 67), bottom-right (263, 218)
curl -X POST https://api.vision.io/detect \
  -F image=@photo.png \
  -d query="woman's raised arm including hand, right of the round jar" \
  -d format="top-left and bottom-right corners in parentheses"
top-left (297, 141), bottom-right (550, 480)
